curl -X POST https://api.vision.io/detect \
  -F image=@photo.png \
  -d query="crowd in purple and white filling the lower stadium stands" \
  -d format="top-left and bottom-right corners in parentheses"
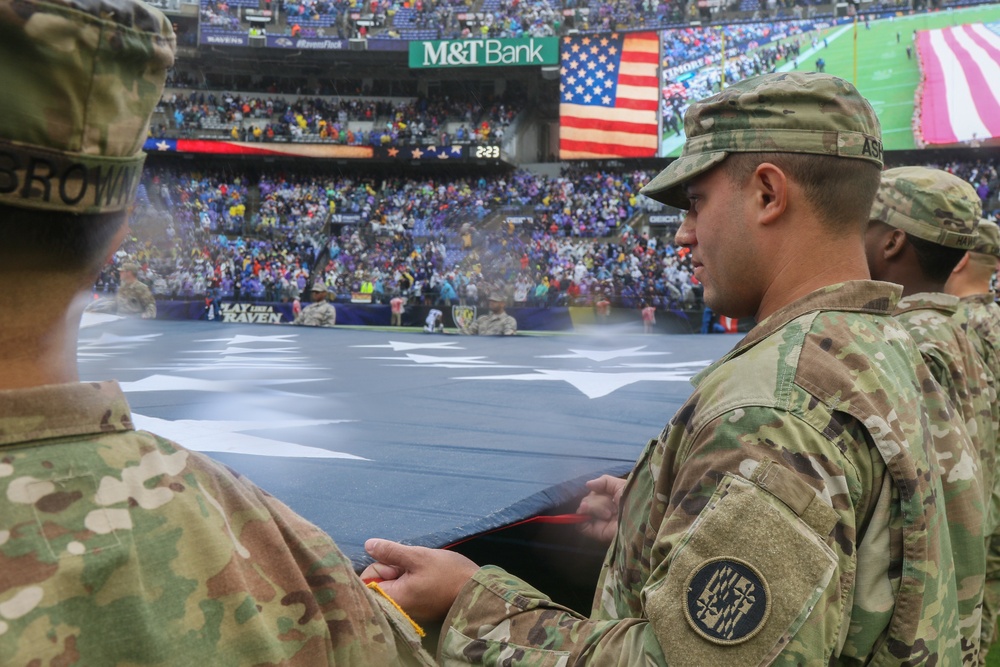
top-left (96, 161), bottom-right (1000, 316)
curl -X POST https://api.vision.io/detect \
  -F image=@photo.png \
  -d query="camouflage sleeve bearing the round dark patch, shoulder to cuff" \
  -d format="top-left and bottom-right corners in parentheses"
top-left (438, 409), bottom-right (880, 665)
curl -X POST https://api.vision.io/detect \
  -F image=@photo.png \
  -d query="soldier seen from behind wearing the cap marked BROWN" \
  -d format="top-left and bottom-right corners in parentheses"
top-left (0, 0), bottom-right (433, 667)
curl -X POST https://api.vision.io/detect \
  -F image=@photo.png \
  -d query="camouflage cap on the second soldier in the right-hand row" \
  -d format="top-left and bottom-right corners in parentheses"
top-left (868, 167), bottom-right (982, 250)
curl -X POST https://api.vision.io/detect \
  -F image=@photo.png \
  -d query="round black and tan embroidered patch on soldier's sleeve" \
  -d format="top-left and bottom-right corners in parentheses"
top-left (684, 557), bottom-right (771, 646)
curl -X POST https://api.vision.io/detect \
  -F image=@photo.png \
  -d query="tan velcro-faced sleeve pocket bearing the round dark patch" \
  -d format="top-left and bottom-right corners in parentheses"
top-left (646, 474), bottom-right (839, 667)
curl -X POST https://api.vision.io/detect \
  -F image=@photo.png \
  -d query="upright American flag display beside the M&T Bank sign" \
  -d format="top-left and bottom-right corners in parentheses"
top-left (559, 32), bottom-right (660, 160)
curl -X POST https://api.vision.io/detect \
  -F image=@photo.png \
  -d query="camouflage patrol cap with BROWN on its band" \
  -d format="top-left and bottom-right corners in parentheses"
top-left (0, 0), bottom-right (175, 213)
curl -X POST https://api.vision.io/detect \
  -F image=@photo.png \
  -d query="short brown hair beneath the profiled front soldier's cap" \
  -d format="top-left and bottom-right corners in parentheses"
top-left (721, 153), bottom-right (881, 233)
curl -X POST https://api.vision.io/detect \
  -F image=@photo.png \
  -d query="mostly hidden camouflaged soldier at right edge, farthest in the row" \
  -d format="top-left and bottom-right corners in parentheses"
top-left (945, 220), bottom-right (1000, 665)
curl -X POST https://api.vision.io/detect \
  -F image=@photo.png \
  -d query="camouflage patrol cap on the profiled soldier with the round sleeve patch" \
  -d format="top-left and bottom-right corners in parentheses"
top-left (641, 72), bottom-right (882, 209)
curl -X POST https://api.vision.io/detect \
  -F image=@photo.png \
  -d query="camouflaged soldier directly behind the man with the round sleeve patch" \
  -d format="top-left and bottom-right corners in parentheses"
top-left (865, 167), bottom-right (1000, 654)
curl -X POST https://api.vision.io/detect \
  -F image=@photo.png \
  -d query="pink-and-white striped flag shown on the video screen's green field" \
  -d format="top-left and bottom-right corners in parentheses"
top-left (915, 23), bottom-right (1000, 144)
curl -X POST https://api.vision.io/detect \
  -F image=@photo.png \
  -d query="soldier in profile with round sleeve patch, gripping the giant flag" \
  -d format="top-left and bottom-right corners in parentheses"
top-left (366, 73), bottom-right (982, 666)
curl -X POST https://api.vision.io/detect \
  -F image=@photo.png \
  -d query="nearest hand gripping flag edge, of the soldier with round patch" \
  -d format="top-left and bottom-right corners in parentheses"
top-left (361, 539), bottom-right (479, 621)
